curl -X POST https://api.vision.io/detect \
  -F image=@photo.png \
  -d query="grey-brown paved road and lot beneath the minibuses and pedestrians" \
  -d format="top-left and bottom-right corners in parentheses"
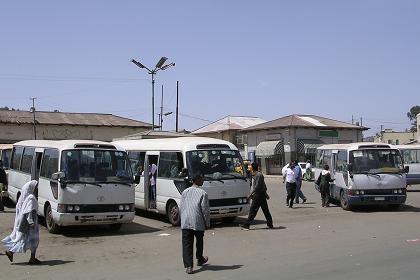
top-left (0, 178), bottom-right (420, 280)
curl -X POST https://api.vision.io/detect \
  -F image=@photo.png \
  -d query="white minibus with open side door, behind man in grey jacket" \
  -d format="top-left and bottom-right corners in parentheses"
top-left (112, 137), bottom-right (250, 225)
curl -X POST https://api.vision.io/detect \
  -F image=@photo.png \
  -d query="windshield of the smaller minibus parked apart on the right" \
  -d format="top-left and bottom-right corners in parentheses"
top-left (350, 149), bottom-right (404, 174)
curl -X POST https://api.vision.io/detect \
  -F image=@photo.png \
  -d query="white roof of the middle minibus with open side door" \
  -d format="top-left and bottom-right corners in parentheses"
top-left (112, 136), bottom-right (238, 151)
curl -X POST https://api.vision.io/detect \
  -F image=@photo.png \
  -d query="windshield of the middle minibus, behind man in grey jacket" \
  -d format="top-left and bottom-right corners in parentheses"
top-left (186, 150), bottom-right (245, 181)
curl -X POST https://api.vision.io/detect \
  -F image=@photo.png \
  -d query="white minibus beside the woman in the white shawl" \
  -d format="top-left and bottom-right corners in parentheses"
top-left (8, 140), bottom-right (134, 233)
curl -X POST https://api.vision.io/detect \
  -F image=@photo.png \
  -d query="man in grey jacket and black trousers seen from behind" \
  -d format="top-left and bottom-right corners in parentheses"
top-left (180, 173), bottom-right (210, 274)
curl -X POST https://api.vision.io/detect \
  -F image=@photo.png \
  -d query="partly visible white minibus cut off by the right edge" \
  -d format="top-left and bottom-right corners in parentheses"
top-left (395, 144), bottom-right (420, 185)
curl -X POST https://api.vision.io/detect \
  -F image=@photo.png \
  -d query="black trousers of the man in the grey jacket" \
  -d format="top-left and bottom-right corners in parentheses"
top-left (182, 229), bottom-right (204, 268)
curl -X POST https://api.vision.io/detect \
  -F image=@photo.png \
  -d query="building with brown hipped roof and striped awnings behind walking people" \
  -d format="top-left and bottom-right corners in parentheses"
top-left (242, 115), bottom-right (368, 174)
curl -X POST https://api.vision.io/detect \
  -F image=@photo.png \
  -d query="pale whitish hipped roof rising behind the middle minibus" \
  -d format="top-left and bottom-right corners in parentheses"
top-left (192, 116), bottom-right (265, 134)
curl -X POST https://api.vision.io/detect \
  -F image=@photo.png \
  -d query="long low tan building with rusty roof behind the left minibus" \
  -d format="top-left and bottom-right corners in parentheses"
top-left (0, 110), bottom-right (151, 143)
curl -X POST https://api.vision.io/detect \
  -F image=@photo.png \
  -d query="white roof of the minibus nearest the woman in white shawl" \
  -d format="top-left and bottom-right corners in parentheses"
top-left (13, 140), bottom-right (116, 150)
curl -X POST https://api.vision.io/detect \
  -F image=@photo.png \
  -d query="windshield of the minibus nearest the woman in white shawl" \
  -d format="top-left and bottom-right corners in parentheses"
top-left (61, 149), bottom-right (133, 184)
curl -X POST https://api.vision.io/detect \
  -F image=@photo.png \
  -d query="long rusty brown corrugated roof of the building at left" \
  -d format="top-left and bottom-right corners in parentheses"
top-left (0, 110), bottom-right (151, 128)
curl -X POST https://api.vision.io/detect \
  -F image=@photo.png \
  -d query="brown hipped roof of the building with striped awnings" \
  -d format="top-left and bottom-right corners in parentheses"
top-left (245, 115), bottom-right (369, 131)
